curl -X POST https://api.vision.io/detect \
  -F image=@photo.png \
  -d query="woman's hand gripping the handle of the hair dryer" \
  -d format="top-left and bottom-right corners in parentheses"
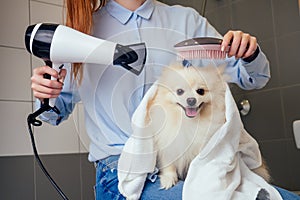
top-left (31, 66), bottom-right (67, 101)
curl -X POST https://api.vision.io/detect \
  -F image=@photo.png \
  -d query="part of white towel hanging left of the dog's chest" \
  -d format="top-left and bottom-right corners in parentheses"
top-left (118, 82), bottom-right (157, 200)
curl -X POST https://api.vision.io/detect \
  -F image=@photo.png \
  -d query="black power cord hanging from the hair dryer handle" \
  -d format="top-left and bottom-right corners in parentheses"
top-left (27, 103), bottom-right (68, 200)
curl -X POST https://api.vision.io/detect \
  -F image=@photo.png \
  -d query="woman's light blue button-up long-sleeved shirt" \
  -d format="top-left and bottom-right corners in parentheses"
top-left (41, 0), bottom-right (270, 161)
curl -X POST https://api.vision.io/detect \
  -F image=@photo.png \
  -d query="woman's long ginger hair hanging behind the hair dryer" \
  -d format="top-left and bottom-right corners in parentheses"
top-left (64, 0), bottom-right (106, 83)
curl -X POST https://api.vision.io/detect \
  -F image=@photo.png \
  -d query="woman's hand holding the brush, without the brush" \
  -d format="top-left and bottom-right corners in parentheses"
top-left (222, 31), bottom-right (257, 58)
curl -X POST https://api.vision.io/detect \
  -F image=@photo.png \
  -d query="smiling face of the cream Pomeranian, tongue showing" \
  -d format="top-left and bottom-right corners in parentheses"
top-left (159, 63), bottom-right (224, 118)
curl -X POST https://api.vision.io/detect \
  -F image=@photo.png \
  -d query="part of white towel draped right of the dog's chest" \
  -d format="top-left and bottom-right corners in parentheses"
top-left (183, 87), bottom-right (282, 200)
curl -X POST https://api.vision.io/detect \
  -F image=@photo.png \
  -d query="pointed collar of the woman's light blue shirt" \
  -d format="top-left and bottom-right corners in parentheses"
top-left (105, 0), bottom-right (154, 24)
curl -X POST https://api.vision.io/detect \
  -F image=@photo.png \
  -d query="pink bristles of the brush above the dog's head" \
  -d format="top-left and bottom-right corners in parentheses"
top-left (178, 50), bottom-right (227, 60)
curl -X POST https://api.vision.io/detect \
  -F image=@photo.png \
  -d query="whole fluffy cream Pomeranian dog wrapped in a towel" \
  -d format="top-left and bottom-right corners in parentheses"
top-left (147, 64), bottom-right (269, 189)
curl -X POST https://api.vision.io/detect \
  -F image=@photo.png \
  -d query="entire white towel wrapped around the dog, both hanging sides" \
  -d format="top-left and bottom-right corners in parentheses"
top-left (118, 83), bottom-right (282, 200)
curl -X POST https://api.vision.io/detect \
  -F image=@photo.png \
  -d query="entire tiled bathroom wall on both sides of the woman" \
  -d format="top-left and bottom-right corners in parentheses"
top-left (0, 0), bottom-right (300, 200)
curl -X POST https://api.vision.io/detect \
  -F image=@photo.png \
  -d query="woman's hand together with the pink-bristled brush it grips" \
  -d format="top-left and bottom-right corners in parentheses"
top-left (174, 31), bottom-right (259, 62)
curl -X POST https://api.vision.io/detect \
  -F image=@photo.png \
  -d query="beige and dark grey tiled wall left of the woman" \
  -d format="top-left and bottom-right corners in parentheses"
top-left (0, 0), bottom-right (95, 200)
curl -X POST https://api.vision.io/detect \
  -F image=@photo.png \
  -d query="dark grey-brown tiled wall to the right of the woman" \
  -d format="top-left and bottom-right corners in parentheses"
top-left (164, 0), bottom-right (300, 191)
